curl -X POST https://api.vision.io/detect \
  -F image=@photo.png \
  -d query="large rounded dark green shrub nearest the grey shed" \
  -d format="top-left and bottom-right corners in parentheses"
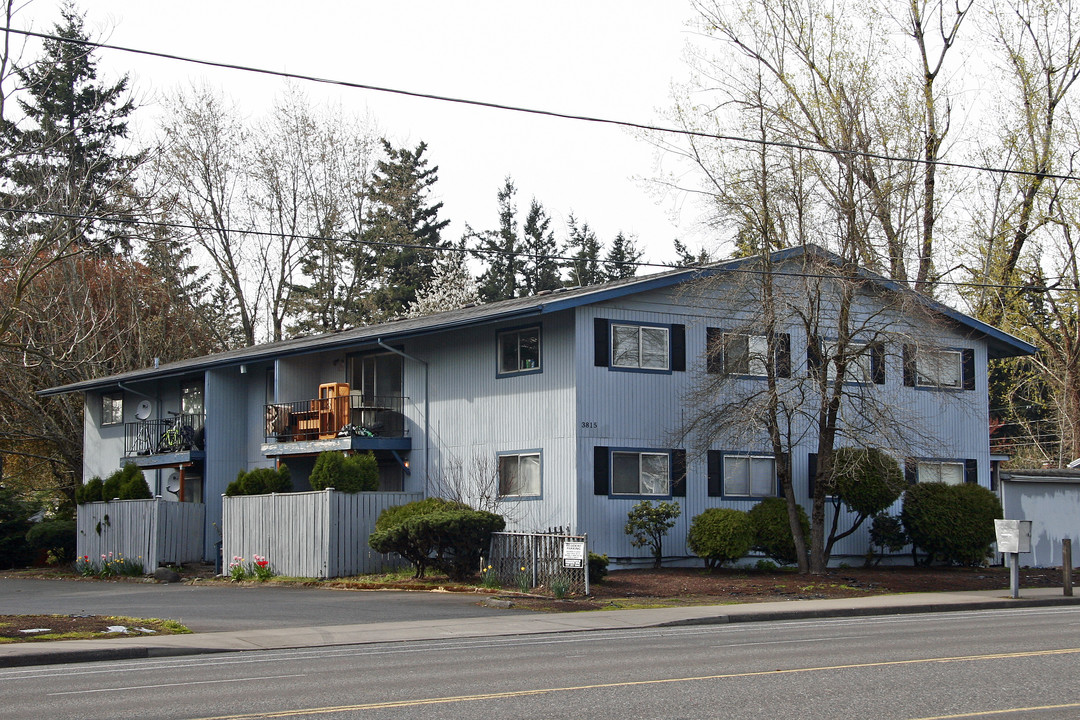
top-left (901, 483), bottom-right (1002, 566)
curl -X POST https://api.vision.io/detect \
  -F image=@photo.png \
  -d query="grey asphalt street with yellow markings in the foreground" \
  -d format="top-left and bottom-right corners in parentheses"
top-left (0, 607), bottom-right (1080, 720)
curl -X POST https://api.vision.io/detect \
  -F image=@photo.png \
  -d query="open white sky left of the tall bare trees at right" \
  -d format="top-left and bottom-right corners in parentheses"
top-left (12, 0), bottom-right (715, 267)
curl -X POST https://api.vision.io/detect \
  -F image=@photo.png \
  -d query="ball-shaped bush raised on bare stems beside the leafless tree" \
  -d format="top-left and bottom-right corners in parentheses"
top-left (833, 448), bottom-right (907, 517)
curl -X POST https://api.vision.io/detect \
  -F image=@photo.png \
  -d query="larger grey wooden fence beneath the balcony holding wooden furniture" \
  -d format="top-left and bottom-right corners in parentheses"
top-left (221, 490), bottom-right (423, 578)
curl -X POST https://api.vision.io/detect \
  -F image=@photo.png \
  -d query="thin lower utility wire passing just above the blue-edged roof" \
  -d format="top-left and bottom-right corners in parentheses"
top-left (0, 206), bottom-right (1080, 293)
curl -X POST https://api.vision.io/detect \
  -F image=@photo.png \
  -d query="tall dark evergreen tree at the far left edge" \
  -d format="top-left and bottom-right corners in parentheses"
top-left (3, 3), bottom-right (143, 252)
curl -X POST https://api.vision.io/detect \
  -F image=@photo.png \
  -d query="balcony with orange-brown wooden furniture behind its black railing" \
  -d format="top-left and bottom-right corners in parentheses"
top-left (262, 395), bottom-right (413, 456)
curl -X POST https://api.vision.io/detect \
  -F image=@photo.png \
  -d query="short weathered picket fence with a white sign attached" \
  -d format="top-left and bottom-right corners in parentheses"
top-left (483, 528), bottom-right (589, 595)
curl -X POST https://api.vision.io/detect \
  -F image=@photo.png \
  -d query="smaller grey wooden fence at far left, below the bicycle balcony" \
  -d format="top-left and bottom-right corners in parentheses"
top-left (76, 498), bottom-right (206, 573)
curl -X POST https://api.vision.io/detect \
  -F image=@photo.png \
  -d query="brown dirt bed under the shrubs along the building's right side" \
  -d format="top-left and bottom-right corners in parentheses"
top-left (500, 567), bottom-right (1062, 612)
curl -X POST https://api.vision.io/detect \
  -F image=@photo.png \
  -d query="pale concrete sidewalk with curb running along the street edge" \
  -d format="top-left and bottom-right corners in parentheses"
top-left (0, 587), bottom-right (1080, 667)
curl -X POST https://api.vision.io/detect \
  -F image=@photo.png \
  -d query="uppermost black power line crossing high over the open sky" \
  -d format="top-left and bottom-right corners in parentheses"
top-left (6, 27), bottom-right (1080, 185)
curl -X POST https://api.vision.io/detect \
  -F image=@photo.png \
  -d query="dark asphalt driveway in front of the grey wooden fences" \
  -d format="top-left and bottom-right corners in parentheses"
top-left (0, 579), bottom-right (513, 633)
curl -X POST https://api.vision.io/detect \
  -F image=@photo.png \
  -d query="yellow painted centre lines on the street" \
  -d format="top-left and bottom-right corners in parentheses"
top-left (190, 648), bottom-right (1080, 720)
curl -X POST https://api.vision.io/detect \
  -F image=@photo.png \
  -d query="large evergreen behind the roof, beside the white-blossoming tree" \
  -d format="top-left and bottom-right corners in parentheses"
top-left (364, 140), bottom-right (449, 321)
